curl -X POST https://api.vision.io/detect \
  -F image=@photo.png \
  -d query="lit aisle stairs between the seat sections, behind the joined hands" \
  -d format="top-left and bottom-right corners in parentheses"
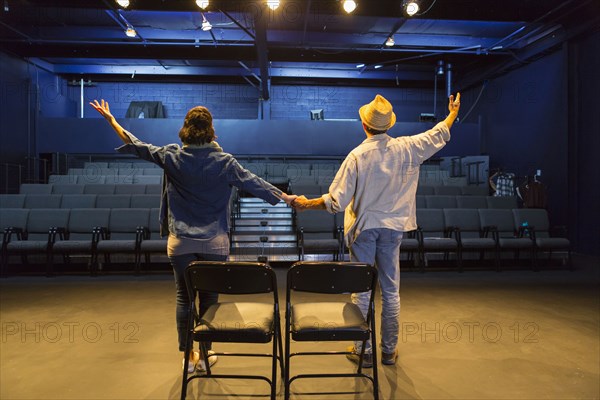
top-left (230, 197), bottom-right (298, 262)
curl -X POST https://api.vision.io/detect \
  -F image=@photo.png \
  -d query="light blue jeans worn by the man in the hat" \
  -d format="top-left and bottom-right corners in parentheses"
top-left (350, 228), bottom-right (402, 353)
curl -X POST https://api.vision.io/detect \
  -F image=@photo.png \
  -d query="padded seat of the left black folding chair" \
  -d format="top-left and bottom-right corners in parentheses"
top-left (194, 302), bottom-right (274, 343)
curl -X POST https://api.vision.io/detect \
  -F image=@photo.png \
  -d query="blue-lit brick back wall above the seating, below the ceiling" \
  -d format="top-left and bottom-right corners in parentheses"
top-left (72, 80), bottom-right (433, 121)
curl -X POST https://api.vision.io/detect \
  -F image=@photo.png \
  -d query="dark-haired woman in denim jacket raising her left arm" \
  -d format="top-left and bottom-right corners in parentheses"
top-left (90, 100), bottom-right (296, 372)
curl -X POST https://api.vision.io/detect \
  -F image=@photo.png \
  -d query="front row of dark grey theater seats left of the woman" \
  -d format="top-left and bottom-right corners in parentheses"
top-left (0, 208), bottom-right (167, 275)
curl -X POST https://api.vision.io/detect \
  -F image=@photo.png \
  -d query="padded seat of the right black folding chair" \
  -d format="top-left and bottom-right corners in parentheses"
top-left (291, 302), bottom-right (370, 341)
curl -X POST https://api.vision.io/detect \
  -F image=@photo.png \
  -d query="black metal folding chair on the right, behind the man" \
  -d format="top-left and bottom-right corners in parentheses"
top-left (285, 262), bottom-right (379, 400)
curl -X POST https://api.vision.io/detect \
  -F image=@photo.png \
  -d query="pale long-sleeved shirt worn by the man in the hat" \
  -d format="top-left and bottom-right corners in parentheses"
top-left (322, 122), bottom-right (450, 245)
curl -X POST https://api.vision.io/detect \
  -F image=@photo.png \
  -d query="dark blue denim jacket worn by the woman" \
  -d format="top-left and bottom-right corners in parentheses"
top-left (116, 132), bottom-right (282, 239)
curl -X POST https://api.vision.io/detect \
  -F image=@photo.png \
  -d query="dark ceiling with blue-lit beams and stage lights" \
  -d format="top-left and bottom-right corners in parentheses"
top-left (0, 0), bottom-right (600, 97)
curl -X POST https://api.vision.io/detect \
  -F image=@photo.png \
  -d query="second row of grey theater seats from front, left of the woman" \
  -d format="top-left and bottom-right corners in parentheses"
top-left (0, 194), bottom-right (160, 209)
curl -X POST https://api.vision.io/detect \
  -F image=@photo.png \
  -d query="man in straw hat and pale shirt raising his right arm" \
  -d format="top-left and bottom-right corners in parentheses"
top-left (292, 93), bottom-right (460, 368)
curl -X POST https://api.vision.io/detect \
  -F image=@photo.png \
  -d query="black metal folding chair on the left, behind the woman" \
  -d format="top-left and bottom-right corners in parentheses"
top-left (181, 261), bottom-right (283, 399)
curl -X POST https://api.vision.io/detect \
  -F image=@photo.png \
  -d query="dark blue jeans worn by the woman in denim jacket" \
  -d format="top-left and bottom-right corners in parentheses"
top-left (169, 253), bottom-right (227, 351)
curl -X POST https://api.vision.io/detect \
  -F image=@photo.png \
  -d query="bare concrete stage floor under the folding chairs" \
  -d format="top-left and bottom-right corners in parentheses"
top-left (0, 256), bottom-right (600, 400)
